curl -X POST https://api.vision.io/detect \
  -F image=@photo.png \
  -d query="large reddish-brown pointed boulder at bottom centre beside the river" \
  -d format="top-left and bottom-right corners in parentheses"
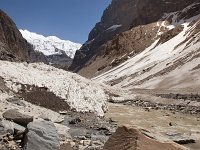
top-left (103, 126), bottom-right (188, 150)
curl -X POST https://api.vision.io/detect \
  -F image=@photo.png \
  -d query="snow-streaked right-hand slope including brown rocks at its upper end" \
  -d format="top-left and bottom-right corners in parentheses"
top-left (93, 3), bottom-right (200, 90)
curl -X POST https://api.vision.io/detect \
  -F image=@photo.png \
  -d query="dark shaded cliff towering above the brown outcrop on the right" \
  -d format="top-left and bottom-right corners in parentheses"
top-left (70, 0), bottom-right (196, 75)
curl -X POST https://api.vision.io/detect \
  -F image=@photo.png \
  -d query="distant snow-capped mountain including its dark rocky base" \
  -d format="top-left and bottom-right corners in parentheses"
top-left (19, 29), bottom-right (81, 70)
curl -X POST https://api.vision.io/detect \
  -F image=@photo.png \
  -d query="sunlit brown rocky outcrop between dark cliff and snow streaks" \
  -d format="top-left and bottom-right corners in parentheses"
top-left (79, 23), bottom-right (159, 78)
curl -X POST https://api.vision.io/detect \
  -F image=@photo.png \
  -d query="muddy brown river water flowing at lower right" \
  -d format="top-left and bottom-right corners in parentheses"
top-left (106, 103), bottom-right (200, 150)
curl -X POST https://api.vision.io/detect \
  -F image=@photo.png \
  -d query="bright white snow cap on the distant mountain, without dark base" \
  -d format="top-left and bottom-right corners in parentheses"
top-left (19, 29), bottom-right (81, 58)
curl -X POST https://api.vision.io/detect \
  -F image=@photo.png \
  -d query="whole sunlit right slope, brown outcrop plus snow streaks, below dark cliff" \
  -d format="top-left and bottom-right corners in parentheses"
top-left (93, 1), bottom-right (200, 92)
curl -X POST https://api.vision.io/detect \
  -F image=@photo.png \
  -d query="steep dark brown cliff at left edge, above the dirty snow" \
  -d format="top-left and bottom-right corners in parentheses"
top-left (0, 10), bottom-right (32, 61)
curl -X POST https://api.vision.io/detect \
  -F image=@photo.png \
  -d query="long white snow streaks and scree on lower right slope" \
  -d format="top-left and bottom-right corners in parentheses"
top-left (93, 11), bottom-right (200, 89)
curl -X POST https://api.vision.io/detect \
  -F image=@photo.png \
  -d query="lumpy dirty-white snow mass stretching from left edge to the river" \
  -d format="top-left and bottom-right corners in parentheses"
top-left (0, 61), bottom-right (107, 116)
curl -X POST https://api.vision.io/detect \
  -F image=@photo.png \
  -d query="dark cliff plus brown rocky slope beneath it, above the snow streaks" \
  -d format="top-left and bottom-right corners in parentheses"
top-left (71, 0), bottom-right (198, 77)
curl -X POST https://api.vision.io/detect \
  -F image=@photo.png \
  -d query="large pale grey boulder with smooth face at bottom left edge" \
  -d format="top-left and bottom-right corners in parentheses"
top-left (24, 121), bottom-right (60, 150)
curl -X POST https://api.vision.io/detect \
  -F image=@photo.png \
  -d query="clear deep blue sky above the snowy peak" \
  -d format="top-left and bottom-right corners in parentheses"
top-left (0, 0), bottom-right (111, 43)
